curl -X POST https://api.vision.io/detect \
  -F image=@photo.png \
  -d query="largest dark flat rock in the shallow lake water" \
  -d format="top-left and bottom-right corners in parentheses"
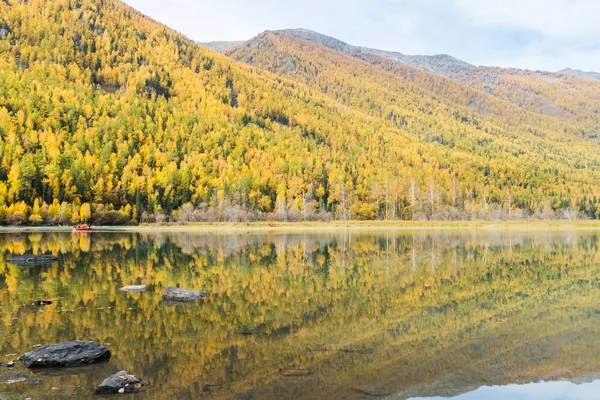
top-left (19, 340), bottom-right (111, 368)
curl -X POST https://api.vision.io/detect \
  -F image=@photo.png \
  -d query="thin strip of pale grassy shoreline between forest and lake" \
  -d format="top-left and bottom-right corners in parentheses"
top-left (0, 221), bottom-right (600, 233)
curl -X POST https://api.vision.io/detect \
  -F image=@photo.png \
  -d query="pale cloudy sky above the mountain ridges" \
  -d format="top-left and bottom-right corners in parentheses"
top-left (120, 0), bottom-right (600, 71)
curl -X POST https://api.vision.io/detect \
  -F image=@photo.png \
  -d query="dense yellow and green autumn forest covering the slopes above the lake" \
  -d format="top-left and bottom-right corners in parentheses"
top-left (0, 0), bottom-right (600, 224)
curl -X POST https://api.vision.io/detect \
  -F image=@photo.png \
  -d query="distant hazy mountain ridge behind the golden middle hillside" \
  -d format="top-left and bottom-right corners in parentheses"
top-left (225, 29), bottom-right (600, 125)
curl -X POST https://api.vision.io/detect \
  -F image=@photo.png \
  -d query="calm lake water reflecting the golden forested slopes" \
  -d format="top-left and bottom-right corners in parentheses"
top-left (0, 230), bottom-right (600, 400)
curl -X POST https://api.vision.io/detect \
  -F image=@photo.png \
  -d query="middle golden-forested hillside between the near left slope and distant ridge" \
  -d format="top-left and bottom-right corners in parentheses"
top-left (228, 32), bottom-right (600, 219)
